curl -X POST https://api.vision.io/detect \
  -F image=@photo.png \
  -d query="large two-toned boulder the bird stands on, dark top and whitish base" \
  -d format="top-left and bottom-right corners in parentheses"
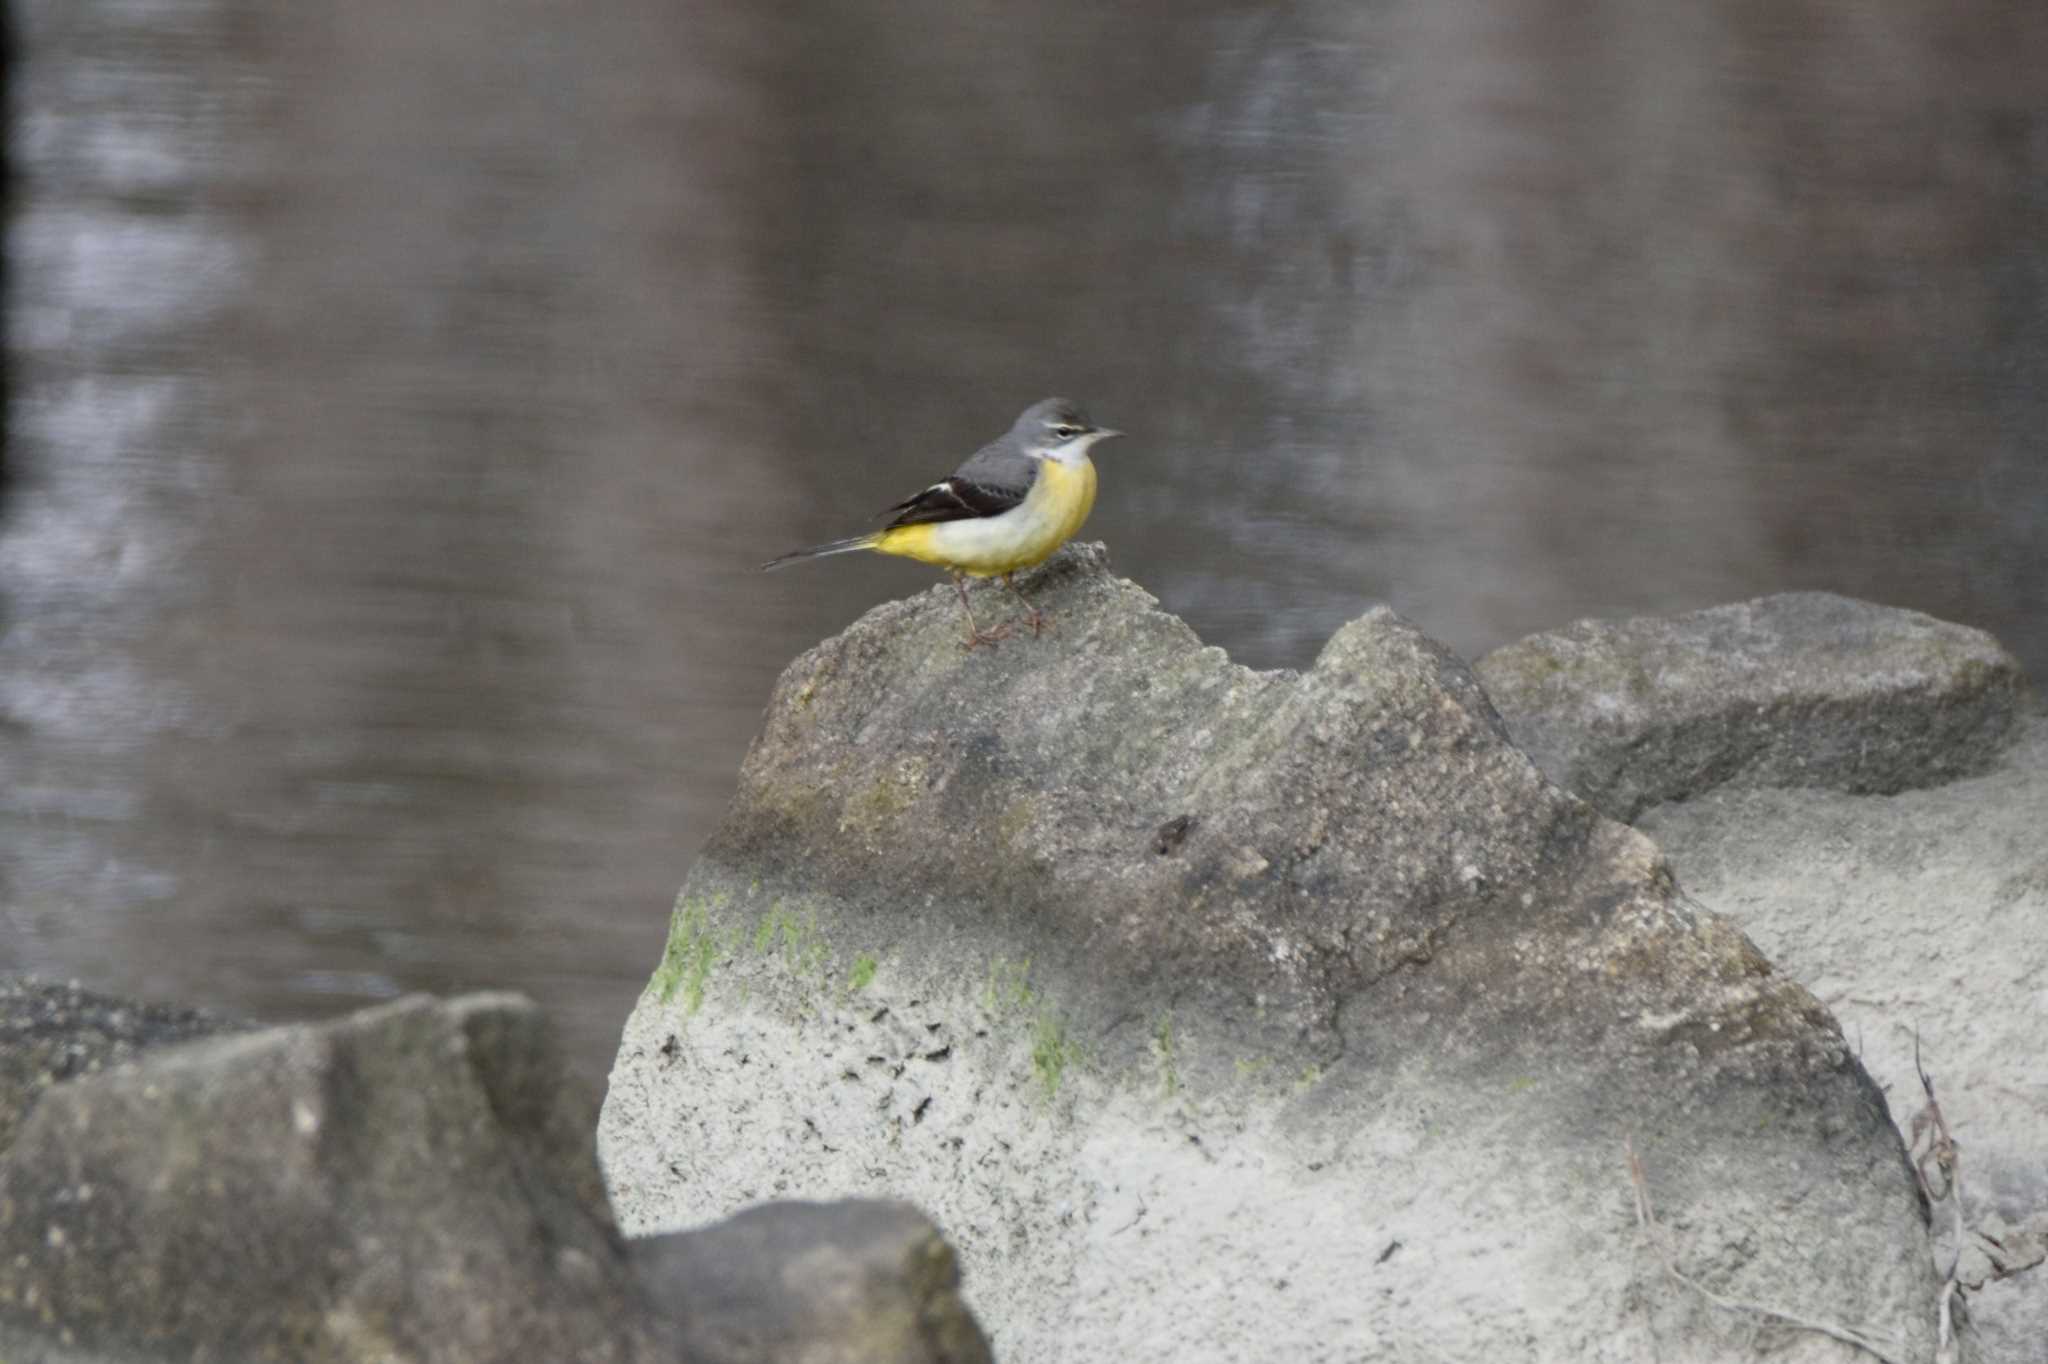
top-left (600, 547), bottom-right (1935, 1364)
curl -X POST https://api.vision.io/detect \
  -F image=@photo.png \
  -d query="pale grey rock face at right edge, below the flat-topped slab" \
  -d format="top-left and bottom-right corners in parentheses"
top-left (1640, 715), bottom-right (2048, 1364)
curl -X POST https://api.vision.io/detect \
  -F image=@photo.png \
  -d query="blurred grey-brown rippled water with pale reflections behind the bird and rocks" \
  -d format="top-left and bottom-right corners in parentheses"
top-left (0, 0), bottom-right (2048, 1073)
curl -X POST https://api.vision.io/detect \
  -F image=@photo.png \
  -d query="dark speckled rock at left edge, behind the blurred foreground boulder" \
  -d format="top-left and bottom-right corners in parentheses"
top-left (0, 977), bottom-right (248, 1151)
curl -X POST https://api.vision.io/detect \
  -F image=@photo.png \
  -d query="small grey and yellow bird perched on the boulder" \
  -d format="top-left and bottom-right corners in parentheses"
top-left (762, 397), bottom-right (1122, 649)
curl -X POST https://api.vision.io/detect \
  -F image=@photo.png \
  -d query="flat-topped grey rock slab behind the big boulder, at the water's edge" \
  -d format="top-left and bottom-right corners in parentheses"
top-left (1475, 592), bottom-right (2025, 819)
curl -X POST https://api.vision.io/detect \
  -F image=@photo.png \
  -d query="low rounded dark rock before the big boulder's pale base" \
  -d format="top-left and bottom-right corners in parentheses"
top-left (633, 1200), bottom-right (989, 1364)
